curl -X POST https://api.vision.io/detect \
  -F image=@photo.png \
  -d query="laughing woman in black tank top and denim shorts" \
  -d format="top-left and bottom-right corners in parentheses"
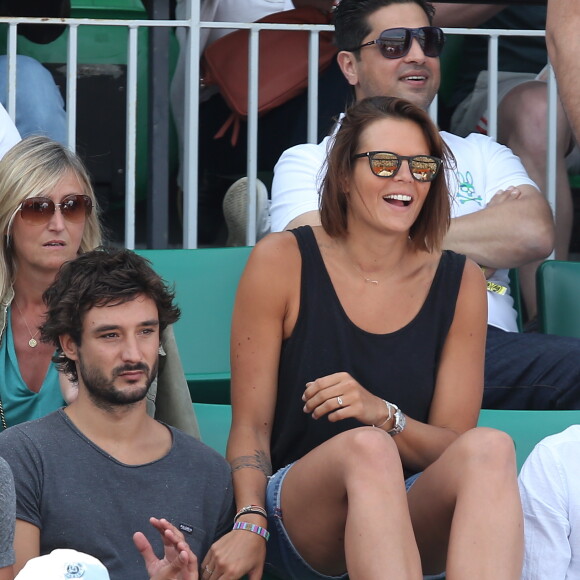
top-left (202, 97), bottom-right (523, 580)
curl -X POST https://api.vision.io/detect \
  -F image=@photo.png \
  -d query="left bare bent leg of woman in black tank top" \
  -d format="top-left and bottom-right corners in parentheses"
top-left (282, 427), bottom-right (422, 580)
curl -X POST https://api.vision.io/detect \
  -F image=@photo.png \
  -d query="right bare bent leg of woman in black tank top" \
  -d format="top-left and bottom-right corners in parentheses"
top-left (408, 428), bottom-right (523, 580)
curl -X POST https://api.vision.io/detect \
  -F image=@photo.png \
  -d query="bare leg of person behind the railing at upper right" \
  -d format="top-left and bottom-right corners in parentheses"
top-left (498, 81), bottom-right (574, 318)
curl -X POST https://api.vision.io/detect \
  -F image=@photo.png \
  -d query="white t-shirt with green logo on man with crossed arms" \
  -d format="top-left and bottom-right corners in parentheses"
top-left (270, 125), bottom-right (537, 332)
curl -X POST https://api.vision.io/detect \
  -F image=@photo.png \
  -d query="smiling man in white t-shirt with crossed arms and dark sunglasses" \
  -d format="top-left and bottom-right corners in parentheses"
top-left (271, 0), bottom-right (580, 409)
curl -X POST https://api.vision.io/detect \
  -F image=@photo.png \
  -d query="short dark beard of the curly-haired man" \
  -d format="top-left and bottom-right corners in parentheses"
top-left (78, 356), bottom-right (159, 411)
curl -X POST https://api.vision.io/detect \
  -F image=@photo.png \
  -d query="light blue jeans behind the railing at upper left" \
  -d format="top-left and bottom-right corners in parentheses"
top-left (0, 55), bottom-right (67, 145)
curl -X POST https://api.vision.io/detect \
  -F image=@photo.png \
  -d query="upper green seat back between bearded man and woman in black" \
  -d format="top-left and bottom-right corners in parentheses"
top-left (137, 247), bottom-right (252, 404)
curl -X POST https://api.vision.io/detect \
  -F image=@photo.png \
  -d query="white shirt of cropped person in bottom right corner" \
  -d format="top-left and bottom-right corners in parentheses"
top-left (519, 425), bottom-right (580, 580)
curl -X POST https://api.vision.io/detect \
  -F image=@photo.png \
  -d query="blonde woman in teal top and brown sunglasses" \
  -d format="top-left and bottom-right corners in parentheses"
top-left (0, 136), bottom-right (199, 436)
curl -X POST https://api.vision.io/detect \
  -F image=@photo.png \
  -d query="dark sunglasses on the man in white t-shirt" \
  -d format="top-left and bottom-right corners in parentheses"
top-left (349, 26), bottom-right (445, 58)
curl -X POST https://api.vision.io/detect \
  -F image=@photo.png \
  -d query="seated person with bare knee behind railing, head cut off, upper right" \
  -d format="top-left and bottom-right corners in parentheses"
top-left (435, 2), bottom-right (580, 329)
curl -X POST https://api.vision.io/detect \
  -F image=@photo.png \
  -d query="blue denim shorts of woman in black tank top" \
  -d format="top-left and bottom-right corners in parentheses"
top-left (266, 463), bottom-right (421, 580)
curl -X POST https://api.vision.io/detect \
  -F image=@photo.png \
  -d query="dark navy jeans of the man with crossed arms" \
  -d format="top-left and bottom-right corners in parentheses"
top-left (483, 326), bottom-right (580, 410)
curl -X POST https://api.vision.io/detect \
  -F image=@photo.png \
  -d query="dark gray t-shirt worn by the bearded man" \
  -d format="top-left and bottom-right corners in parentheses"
top-left (0, 410), bottom-right (234, 580)
